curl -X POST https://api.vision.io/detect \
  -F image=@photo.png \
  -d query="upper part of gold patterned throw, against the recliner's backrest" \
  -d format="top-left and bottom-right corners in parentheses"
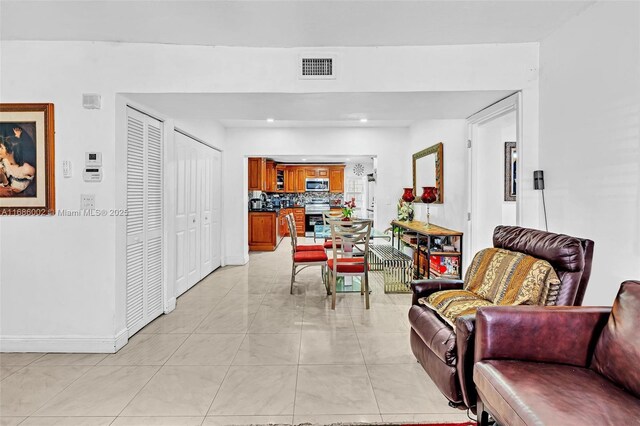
top-left (464, 248), bottom-right (560, 305)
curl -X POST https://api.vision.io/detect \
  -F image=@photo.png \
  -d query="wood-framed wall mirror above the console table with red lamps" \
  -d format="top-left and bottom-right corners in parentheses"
top-left (413, 142), bottom-right (444, 204)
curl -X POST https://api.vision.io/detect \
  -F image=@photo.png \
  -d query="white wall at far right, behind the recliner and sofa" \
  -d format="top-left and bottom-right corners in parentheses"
top-left (538, 2), bottom-right (640, 305)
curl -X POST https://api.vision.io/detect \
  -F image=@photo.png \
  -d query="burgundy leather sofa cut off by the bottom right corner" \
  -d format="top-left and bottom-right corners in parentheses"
top-left (473, 281), bottom-right (640, 426)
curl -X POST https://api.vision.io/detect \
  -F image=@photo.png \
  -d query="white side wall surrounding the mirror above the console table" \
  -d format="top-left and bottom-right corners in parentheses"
top-left (408, 120), bottom-right (467, 232)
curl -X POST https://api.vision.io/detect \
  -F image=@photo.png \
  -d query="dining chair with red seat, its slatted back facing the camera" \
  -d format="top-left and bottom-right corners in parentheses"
top-left (327, 219), bottom-right (372, 310)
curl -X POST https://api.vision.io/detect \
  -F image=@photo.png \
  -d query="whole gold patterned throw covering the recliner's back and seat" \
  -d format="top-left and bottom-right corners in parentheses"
top-left (419, 248), bottom-right (560, 330)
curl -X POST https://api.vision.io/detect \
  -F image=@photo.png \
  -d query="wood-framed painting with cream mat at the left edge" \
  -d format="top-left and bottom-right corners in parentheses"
top-left (0, 103), bottom-right (55, 216)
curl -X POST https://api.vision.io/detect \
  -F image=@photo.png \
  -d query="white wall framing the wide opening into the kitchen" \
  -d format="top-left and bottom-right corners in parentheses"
top-left (224, 128), bottom-right (410, 263)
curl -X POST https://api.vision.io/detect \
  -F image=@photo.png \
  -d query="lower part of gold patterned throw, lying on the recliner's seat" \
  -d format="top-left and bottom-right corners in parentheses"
top-left (418, 290), bottom-right (494, 331)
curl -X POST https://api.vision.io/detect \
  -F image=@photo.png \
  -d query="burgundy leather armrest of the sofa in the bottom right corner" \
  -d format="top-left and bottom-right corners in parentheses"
top-left (474, 306), bottom-right (611, 367)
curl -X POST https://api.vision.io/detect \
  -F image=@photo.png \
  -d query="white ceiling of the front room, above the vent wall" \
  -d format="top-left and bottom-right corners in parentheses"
top-left (0, 0), bottom-right (594, 47)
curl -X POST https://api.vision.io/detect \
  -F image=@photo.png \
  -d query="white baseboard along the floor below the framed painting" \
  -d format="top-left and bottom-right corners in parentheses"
top-left (0, 329), bottom-right (129, 353)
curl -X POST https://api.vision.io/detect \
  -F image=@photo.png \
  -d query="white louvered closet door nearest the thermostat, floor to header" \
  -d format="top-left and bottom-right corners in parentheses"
top-left (126, 108), bottom-right (163, 336)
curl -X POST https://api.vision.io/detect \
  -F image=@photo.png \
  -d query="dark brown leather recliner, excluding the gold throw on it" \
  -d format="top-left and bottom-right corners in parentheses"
top-left (409, 226), bottom-right (593, 411)
